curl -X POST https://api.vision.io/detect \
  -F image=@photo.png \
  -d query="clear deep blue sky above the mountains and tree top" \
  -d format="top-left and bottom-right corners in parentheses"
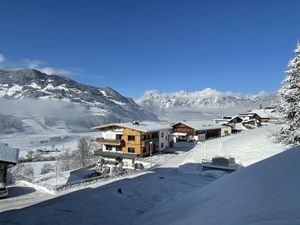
top-left (0, 0), bottom-right (300, 98)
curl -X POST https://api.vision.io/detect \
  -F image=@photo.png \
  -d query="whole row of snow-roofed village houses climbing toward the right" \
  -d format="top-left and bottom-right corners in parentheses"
top-left (92, 106), bottom-right (276, 170)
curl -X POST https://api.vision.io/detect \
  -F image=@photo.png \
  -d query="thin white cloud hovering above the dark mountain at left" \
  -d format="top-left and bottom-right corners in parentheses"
top-left (0, 53), bottom-right (75, 76)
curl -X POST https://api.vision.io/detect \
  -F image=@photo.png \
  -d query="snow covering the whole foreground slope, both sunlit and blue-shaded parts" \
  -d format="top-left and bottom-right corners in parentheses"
top-left (0, 126), bottom-right (292, 225)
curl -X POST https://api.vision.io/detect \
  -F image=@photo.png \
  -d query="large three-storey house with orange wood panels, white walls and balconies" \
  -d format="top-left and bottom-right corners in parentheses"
top-left (92, 122), bottom-right (171, 158)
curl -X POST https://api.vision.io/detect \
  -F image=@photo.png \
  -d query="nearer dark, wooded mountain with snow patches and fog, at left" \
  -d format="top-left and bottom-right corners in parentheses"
top-left (0, 69), bottom-right (157, 132)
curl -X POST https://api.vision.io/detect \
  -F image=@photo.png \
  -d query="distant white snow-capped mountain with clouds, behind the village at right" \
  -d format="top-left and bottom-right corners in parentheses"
top-left (136, 88), bottom-right (276, 119)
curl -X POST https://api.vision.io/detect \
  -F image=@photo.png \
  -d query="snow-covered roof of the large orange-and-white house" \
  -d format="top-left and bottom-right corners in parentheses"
top-left (92, 121), bottom-right (171, 133)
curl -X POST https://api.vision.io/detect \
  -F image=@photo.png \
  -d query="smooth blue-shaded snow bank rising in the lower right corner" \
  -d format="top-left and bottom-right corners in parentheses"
top-left (136, 147), bottom-right (300, 225)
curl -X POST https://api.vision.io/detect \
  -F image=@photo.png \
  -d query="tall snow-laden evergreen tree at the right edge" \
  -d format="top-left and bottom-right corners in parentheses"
top-left (278, 43), bottom-right (300, 144)
